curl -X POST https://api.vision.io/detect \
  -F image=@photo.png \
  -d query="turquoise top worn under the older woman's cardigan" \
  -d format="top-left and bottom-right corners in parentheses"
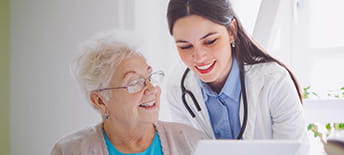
top-left (103, 129), bottom-right (163, 155)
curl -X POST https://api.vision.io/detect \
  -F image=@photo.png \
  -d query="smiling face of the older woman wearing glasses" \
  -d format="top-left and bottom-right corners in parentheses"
top-left (105, 55), bottom-right (161, 124)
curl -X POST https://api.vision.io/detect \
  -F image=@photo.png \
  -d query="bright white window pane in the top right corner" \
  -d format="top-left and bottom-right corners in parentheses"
top-left (309, 0), bottom-right (344, 48)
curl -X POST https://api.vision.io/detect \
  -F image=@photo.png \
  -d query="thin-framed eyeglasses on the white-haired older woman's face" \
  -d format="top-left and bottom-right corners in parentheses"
top-left (94, 71), bottom-right (165, 94)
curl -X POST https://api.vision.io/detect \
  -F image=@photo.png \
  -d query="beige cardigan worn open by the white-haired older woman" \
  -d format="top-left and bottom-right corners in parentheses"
top-left (51, 121), bottom-right (206, 155)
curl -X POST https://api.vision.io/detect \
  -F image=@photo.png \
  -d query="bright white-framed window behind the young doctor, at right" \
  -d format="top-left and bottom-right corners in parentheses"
top-left (253, 0), bottom-right (344, 98)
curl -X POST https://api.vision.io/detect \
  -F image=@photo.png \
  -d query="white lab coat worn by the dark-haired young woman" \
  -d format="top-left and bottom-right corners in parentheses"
top-left (166, 63), bottom-right (308, 144)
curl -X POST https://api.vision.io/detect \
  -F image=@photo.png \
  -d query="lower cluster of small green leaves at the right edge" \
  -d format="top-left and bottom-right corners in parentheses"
top-left (307, 123), bottom-right (344, 144)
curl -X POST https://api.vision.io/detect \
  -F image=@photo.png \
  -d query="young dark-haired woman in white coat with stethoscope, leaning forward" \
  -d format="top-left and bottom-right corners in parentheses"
top-left (167, 0), bottom-right (308, 142)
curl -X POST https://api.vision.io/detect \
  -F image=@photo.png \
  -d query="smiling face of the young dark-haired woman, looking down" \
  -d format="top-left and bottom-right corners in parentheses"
top-left (173, 15), bottom-right (233, 86)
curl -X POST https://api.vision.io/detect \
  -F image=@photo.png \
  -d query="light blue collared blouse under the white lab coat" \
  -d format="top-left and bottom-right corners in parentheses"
top-left (199, 58), bottom-right (241, 139)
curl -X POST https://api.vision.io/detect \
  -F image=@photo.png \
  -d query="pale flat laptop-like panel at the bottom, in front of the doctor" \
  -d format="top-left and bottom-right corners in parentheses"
top-left (193, 140), bottom-right (301, 155)
